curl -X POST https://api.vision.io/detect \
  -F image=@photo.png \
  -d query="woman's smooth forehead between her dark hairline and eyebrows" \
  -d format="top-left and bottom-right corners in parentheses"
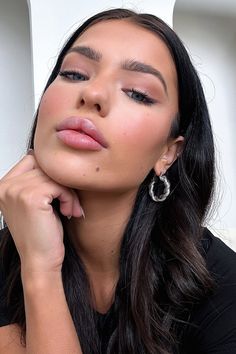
top-left (73, 19), bottom-right (176, 78)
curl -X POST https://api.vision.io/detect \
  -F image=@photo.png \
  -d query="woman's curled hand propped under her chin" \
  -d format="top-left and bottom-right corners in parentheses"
top-left (0, 152), bottom-right (82, 272)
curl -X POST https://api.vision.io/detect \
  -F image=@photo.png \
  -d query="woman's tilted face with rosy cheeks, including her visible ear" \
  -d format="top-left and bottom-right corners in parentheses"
top-left (34, 20), bottom-right (181, 192)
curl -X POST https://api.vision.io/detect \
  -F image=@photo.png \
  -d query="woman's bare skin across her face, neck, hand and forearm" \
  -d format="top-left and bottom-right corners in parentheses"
top-left (0, 20), bottom-right (183, 353)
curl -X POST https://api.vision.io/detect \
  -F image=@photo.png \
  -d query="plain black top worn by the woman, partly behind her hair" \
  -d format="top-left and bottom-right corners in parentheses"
top-left (0, 230), bottom-right (236, 354)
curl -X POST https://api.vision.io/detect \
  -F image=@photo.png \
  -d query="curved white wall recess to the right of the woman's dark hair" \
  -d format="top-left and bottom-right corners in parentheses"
top-left (174, 5), bottom-right (236, 249)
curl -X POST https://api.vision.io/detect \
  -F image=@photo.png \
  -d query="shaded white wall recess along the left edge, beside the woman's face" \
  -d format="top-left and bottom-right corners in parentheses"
top-left (0, 0), bottom-right (34, 176)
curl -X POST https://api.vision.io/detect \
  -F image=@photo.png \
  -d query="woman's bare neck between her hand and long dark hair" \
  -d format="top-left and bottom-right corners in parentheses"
top-left (66, 191), bottom-right (136, 313)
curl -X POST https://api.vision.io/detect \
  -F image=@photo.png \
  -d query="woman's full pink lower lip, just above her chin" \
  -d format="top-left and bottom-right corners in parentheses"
top-left (56, 129), bottom-right (102, 151)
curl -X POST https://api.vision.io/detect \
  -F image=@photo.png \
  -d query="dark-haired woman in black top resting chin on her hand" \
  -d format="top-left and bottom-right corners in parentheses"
top-left (0, 9), bottom-right (236, 354)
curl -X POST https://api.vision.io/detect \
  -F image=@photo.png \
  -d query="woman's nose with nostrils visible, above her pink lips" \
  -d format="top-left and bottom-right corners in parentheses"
top-left (79, 79), bottom-right (110, 117)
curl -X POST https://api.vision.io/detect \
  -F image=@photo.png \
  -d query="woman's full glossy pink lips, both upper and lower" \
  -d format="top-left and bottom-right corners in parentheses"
top-left (56, 116), bottom-right (108, 150)
